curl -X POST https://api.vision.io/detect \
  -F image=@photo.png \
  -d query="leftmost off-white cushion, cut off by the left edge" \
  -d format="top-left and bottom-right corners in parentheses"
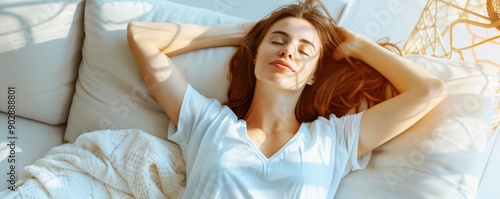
top-left (0, 0), bottom-right (84, 125)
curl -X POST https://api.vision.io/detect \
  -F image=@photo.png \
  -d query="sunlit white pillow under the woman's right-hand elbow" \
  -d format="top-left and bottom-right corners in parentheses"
top-left (335, 55), bottom-right (497, 199)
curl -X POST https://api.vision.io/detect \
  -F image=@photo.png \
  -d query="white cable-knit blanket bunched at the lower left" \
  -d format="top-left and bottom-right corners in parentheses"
top-left (0, 129), bottom-right (186, 198)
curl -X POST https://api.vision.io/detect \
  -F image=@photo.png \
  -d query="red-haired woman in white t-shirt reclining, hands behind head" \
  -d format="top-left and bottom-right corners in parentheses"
top-left (128, 0), bottom-right (446, 198)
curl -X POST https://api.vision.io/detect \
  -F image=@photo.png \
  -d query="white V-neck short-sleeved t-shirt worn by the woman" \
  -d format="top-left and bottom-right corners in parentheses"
top-left (168, 85), bottom-right (371, 199)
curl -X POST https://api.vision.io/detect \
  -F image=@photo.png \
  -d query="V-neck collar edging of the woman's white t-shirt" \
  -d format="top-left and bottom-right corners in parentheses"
top-left (239, 120), bottom-right (306, 162)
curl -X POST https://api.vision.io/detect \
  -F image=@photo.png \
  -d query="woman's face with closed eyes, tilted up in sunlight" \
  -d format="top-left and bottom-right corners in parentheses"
top-left (255, 17), bottom-right (321, 91)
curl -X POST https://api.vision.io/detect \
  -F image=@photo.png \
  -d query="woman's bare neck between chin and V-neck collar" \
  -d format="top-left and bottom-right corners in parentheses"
top-left (244, 82), bottom-right (300, 133)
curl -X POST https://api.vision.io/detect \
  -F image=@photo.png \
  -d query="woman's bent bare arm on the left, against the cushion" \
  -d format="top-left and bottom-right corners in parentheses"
top-left (127, 22), bottom-right (252, 124)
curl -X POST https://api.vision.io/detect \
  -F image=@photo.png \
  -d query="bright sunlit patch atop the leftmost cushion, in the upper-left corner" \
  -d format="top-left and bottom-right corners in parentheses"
top-left (0, 2), bottom-right (79, 53)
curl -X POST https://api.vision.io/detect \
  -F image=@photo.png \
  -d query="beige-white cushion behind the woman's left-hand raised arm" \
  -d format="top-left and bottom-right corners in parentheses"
top-left (64, 0), bottom-right (243, 142)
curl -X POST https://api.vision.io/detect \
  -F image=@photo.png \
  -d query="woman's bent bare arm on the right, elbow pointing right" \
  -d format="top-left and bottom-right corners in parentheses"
top-left (334, 27), bottom-right (447, 156)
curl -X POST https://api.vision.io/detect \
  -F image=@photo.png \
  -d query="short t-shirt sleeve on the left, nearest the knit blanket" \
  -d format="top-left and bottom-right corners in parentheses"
top-left (168, 84), bottom-right (222, 151)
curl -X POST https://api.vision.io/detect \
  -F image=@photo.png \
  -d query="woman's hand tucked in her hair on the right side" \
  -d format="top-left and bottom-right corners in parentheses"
top-left (333, 26), bottom-right (376, 60)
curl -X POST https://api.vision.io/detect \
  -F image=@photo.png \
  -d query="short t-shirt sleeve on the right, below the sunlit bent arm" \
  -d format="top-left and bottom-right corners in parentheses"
top-left (330, 111), bottom-right (371, 176)
